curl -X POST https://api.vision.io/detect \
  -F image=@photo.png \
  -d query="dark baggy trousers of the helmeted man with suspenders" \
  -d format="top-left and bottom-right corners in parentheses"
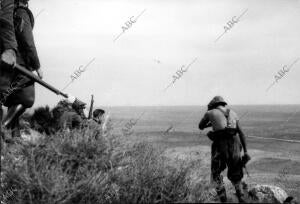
top-left (211, 133), bottom-right (243, 191)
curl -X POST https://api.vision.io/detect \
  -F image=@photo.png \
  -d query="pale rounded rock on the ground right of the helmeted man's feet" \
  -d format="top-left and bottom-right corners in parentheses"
top-left (249, 185), bottom-right (288, 203)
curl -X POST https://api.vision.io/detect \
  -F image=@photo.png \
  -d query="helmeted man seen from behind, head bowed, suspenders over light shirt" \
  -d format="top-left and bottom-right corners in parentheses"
top-left (199, 96), bottom-right (250, 203)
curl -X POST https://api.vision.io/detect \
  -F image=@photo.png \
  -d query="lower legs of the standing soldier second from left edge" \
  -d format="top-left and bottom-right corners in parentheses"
top-left (2, 104), bottom-right (26, 137)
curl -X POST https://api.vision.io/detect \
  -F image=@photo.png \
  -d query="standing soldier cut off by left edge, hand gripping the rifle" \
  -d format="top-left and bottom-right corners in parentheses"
top-left (0, 0), bottom-right (17, 137)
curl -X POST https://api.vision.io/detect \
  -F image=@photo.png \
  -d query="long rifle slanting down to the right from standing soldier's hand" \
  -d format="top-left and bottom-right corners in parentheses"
top-left (15, 64), bottom-right (85, 104)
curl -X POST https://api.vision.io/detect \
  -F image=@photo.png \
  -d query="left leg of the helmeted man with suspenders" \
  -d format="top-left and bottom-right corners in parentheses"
top-left (211, 142), bottom-right (227, 202)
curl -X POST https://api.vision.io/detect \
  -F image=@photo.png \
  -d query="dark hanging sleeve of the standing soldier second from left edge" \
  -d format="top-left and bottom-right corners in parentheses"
top-left (16, 9), bottom-right (40, 70)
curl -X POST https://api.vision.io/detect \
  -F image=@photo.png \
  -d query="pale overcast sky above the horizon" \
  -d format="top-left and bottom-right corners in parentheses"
top-left (30, 0), bottom-right (300, 106)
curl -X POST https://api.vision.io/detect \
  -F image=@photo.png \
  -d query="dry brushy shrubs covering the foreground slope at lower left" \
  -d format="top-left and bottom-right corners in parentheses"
top-left (1, 122), bottom-right (206, 204)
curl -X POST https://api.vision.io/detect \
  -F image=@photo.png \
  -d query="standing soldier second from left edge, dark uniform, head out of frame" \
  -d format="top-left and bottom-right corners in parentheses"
top-left (2, 0), bottom-right (42, 137)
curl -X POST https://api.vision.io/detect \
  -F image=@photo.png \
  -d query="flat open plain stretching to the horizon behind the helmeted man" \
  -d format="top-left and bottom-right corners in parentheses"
top-left (106, 105), bottom-right (300, 199)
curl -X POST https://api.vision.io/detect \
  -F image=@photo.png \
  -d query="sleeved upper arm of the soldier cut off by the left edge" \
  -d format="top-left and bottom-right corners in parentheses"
top-left (0, 0), bottom-right (18, 51)
